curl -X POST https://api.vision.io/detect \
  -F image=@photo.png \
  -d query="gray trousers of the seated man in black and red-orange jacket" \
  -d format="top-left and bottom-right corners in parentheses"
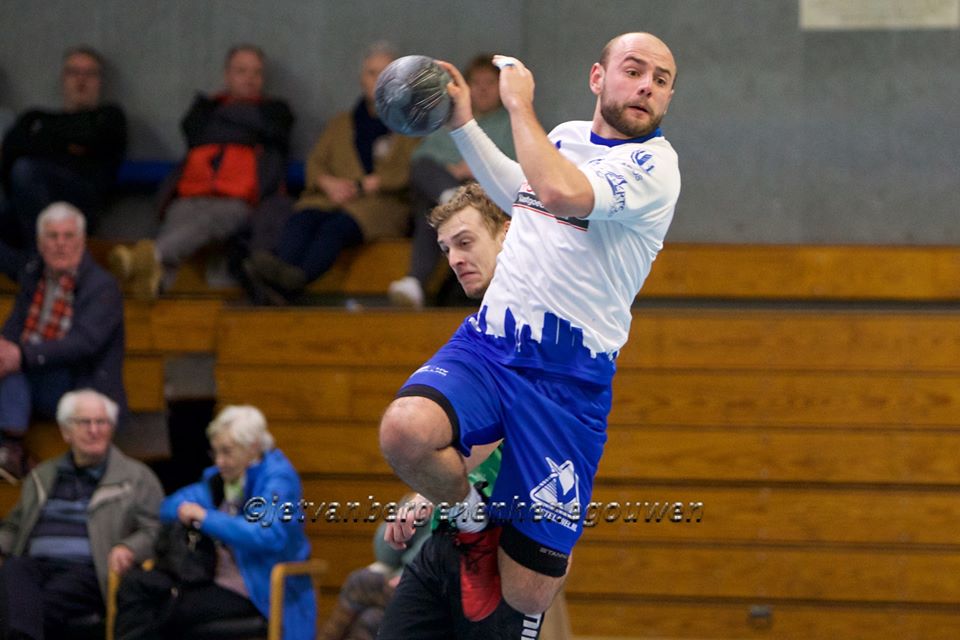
top-left (157, 197), bottom-right (253, 270)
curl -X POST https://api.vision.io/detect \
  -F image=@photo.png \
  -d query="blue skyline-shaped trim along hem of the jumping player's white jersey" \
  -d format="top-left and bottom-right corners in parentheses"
top-left (470, 306), bottom-right (617, 385)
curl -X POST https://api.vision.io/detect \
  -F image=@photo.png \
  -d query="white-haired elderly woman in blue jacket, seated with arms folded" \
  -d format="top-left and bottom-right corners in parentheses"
top-left (116, 406), bottom-right (317, 640)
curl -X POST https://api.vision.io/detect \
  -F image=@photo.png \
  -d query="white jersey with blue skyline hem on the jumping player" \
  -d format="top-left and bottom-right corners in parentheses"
top-left (448, 121), bottom-right (680, 383)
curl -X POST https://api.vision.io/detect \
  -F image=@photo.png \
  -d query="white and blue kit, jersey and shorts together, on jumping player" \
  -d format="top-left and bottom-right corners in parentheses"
top-left (399, 122), bottom-right (680, 560)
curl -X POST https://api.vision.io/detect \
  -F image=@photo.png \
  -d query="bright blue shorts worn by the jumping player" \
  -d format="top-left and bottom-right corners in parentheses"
top-left (398, 329), bottom-right (611, 575)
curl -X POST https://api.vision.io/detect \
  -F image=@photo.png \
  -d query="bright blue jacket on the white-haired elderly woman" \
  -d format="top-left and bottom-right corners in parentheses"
top-left (160, 449), bottom-right (317, 640)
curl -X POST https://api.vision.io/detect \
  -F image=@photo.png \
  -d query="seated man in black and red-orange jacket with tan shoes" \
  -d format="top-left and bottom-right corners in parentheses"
top-left (110, 44), bottom-right (293, 298)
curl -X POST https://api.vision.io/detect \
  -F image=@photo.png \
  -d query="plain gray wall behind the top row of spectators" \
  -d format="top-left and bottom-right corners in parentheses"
top-left (0, 0), bottom-right (960, 244)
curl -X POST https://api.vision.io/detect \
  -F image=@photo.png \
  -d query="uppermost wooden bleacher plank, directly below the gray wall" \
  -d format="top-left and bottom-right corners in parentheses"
top-left (9, 244), bottom-right (960, 302)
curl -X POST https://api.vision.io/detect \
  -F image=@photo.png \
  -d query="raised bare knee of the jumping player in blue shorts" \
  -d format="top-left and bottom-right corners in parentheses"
top-left (380, 396), bottom-right (452, 467)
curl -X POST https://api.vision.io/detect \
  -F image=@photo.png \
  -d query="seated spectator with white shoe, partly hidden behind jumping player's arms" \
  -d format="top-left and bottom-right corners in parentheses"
top-left (388, 54), bottom-right (516, 308)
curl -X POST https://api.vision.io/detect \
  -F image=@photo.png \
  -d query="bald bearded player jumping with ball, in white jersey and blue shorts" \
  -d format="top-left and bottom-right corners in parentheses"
top-left (380, 33), bottom-right (680, 619)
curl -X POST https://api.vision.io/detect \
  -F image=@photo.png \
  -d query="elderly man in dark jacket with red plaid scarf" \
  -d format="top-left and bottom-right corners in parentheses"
top-left (0, 202), bottom-right (127, 481)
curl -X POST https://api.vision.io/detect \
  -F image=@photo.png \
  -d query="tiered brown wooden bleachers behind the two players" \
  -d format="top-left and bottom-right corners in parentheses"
top-left (0, 243), bottom-right (960, 640)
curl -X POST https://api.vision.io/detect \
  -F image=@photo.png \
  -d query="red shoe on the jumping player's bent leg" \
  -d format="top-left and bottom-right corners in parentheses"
top-left (455, 527), bottom-right (503, 622)
